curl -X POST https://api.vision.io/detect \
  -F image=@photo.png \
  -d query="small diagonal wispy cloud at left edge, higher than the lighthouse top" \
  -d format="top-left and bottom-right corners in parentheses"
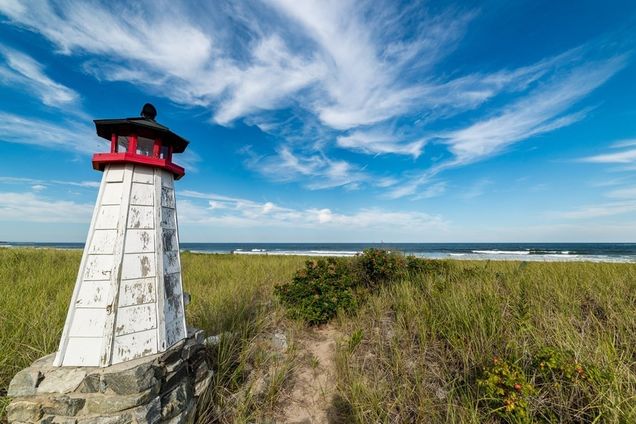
top-left (0, 45), bottom-right (79, 107)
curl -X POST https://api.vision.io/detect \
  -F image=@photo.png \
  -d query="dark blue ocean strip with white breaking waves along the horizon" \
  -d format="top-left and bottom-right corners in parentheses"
top-left (0, 242), bottom-right (636, 263)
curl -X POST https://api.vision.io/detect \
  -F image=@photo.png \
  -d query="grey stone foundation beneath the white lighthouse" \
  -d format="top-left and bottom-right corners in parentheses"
top-left (7, 329), bottom-right (212, 424)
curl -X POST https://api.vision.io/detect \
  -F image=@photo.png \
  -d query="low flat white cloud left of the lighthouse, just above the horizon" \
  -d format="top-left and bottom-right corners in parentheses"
top-left (0, 192), bottom-right (93, 223)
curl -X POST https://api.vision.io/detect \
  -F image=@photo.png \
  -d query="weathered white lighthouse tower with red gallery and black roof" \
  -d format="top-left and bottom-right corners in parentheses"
top-left (54, 104), bottom-right (188, 367)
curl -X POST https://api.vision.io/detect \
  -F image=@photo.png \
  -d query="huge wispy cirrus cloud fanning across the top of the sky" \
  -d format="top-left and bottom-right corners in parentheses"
top-left (0, 0), bottom-right (631, 198)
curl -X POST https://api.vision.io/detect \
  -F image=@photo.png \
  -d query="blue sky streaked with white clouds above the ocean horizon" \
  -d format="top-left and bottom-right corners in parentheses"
top-left (0, 0), bottom-right (636, 242)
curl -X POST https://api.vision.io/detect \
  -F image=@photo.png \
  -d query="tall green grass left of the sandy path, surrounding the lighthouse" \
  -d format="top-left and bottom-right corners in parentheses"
top-left (0, 249), bottom-right (304, 422)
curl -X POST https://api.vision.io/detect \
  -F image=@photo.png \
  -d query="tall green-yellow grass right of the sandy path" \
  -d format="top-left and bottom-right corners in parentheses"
top-left (337, 262), bottom-right (636, 423)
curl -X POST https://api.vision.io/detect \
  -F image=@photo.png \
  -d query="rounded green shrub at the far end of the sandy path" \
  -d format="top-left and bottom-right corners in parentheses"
top-left (274, 258), bottom-right (357, 325)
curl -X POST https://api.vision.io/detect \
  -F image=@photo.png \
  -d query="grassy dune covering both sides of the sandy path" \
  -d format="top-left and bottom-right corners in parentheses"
top-left (0, 249), bottom-right (636, 423)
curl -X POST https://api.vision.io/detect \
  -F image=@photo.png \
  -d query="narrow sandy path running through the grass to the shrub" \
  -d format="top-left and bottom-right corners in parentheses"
top-left (282, 325), bottom-right (340, 423)
